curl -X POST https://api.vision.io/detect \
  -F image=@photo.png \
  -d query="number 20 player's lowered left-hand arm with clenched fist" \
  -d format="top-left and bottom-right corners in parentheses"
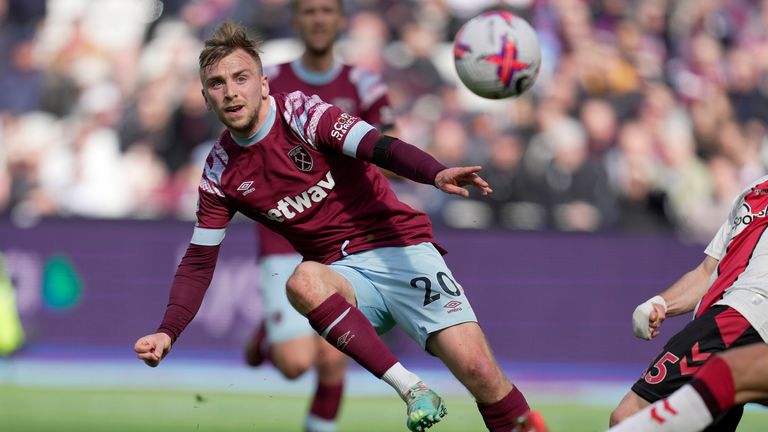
top-left (134, 176), bottom-right (234, 367)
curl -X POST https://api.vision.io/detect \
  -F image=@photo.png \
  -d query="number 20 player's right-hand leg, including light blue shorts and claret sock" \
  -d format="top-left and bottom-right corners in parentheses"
top-left (336, 243), bottom-right (540, 431)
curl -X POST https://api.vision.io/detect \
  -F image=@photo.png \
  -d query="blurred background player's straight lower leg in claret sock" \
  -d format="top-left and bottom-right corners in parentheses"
top-left (305, 335), bottom-right (347, 432)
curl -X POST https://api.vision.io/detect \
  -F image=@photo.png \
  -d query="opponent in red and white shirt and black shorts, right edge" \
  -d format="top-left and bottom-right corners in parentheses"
top-left (611, 176), bottom-right (768, 431)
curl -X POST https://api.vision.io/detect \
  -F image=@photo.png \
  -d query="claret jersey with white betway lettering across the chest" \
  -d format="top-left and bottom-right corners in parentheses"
top-left (192, 91), bottom-right (433, 263)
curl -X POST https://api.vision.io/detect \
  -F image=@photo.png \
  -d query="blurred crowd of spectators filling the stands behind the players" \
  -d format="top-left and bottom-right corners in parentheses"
top-left (0, 0), bottom-right (768, 242)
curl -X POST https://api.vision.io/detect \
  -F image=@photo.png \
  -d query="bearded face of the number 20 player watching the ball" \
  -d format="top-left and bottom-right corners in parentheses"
top-left (200, 49), bottom-right (269, 138)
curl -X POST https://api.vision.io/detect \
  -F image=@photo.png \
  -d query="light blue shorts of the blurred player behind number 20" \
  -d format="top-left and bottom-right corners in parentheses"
top-left (259, 254), bottom-right (317, 344)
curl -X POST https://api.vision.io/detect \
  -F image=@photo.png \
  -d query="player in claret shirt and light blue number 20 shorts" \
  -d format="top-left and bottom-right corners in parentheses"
top-left (134, 22), bottom-right (543, 432)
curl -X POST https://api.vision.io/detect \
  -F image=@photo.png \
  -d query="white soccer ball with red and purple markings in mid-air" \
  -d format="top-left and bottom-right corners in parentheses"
top-left (453, 11), bottom-right (541, 99)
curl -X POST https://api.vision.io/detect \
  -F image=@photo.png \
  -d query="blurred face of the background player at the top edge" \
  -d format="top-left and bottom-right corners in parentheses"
top-left (293, 0), bottom-right (346, 53)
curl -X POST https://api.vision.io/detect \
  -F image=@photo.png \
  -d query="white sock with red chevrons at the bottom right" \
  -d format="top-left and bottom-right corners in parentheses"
top-left (610, 384), bottom-right (712, 432)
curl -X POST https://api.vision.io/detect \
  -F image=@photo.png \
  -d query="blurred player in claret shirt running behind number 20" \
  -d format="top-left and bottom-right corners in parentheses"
top-left (245, 0), bottom-right (392, 432)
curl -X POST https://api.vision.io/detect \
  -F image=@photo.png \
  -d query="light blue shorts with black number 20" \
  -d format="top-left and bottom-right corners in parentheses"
top-left (330, 243), bottom-right (477, 349)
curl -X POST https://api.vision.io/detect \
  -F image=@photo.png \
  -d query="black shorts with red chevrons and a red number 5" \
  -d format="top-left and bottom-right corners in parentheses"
top-left (632, 306), bottom-right (763, 403)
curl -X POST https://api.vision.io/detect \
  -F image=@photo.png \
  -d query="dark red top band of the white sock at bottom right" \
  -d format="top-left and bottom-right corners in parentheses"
top-left (691, 356), bottom-right (736, 418)
